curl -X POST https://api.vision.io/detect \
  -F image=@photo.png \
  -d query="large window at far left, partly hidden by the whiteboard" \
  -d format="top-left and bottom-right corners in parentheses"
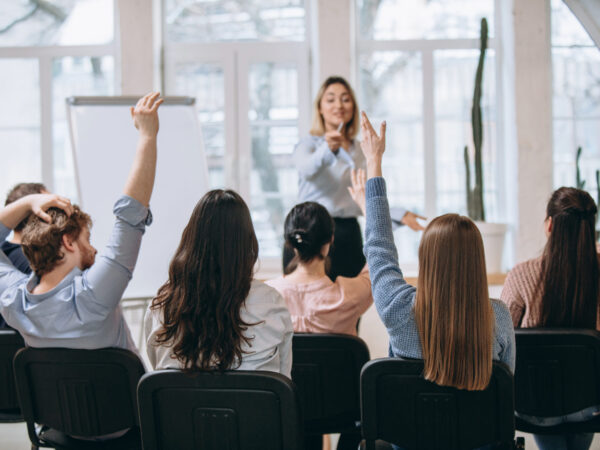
top-left (0, 0), bottom-right (115, 199)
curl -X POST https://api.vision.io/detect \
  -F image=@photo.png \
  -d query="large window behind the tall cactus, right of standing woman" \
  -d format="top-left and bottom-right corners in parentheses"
top-left (356, 0), bottom-right (503, 262)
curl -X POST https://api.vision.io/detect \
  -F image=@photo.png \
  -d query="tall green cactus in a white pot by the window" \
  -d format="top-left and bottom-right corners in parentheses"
top-left (464, 18), bottom-right (507, 273)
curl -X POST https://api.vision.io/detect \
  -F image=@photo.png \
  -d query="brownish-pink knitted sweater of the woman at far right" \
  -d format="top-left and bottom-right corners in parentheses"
top-left (500, 256), bottom-right (600, 330)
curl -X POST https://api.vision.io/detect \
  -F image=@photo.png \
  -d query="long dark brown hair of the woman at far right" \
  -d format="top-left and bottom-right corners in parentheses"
top-left (539, 187), bottom-right (600, 328)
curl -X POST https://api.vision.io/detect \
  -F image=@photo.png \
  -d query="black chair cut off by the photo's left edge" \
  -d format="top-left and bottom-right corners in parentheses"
top-left (0, 330), bottom-right (25, 423)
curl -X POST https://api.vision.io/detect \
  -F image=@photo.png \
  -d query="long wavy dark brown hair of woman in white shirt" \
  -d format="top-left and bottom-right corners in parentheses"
top-left (152, 189), bottom-right (258, 370)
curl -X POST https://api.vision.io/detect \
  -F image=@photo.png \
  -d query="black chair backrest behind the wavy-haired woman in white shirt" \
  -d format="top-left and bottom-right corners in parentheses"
top-left (138, 370), bottom-right (303, 450)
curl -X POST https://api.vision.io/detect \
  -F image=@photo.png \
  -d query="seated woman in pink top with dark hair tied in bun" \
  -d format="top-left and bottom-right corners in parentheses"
top-left (267, 174), bottom-right (373, 336)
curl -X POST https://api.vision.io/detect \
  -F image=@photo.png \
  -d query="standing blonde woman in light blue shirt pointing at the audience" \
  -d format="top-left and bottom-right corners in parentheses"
top-left (283, 76), bottom-right (423, 281)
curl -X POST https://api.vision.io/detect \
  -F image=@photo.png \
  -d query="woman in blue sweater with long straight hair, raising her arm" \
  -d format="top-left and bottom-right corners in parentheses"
top-left (361, 113), bottom-right (515, 390)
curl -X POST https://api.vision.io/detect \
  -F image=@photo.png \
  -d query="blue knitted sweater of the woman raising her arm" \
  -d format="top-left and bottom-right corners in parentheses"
top-left (365, 177), bottom-right (515, 372)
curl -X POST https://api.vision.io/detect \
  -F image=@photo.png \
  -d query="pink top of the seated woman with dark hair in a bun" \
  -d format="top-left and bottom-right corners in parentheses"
top-left (266, 265), bottom-right (373, 336)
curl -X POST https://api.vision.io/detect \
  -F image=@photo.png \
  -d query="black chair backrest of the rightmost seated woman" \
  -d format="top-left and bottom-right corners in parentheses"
top-left (515, 328), bottom-right (600, 417)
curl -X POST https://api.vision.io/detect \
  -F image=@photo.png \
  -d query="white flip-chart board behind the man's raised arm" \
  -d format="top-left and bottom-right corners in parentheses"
top-left (67, 97), bottom-right (209, 298)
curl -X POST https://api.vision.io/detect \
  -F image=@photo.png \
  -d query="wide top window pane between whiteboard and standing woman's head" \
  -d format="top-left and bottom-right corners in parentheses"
top-left (165, 0), bottom-right (305, 42)
